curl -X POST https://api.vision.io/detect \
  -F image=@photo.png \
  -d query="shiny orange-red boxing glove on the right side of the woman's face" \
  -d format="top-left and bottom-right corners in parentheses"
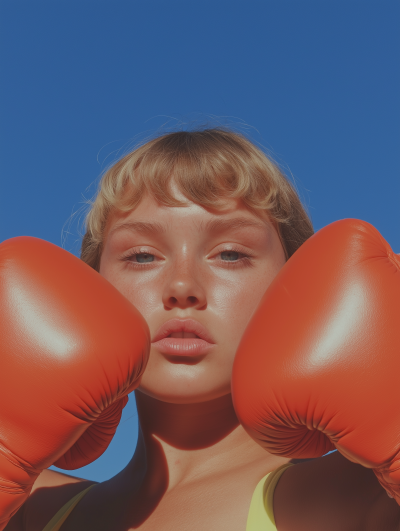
top-left (232, 219), bottom-right (400, 504)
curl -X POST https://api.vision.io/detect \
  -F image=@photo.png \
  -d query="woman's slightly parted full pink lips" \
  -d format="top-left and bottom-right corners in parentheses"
top-left (152, 319), bottom-right (215, 357)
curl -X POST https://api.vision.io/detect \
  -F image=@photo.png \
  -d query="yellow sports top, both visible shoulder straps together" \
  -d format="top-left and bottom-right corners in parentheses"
top-left (43, 463), bottom-right (293, 531)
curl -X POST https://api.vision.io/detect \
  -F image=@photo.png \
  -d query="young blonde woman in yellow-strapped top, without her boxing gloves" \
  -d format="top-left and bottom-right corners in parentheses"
top-left (6, 129), bottom-right (400, 531)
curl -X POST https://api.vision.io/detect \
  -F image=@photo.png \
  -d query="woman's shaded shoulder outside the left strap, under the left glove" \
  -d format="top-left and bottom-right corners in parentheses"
top-left (4, 470), bottom-right (95, 531)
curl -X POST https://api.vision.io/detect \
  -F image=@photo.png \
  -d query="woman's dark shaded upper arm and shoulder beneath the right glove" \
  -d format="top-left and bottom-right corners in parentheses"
top-left (274, 452), bottom-right (400, 531)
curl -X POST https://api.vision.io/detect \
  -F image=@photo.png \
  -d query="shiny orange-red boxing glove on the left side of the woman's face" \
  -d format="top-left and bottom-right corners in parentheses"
top-left (0, 237), bottom-right (150, 530)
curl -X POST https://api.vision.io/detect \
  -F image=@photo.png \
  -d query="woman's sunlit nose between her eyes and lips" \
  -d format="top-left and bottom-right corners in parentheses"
top-left (163, 264), bottom-right (207, 309)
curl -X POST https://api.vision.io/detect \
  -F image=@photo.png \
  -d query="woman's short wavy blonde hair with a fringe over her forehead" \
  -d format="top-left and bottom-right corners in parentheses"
top-left (81, 129), bottom-right (314, 270)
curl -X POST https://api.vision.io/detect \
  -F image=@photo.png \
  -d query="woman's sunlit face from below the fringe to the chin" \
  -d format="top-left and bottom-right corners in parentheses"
top-left (100, 190), bottom-right (285, 403)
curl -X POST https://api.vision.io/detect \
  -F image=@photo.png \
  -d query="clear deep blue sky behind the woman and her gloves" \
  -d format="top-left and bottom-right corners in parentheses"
top-left (0, 0), bottom-right (400, 479)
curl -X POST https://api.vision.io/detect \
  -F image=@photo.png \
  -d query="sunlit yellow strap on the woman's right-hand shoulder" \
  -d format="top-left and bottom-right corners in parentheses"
top-left (246, 463), bottom-right (293, 531)
